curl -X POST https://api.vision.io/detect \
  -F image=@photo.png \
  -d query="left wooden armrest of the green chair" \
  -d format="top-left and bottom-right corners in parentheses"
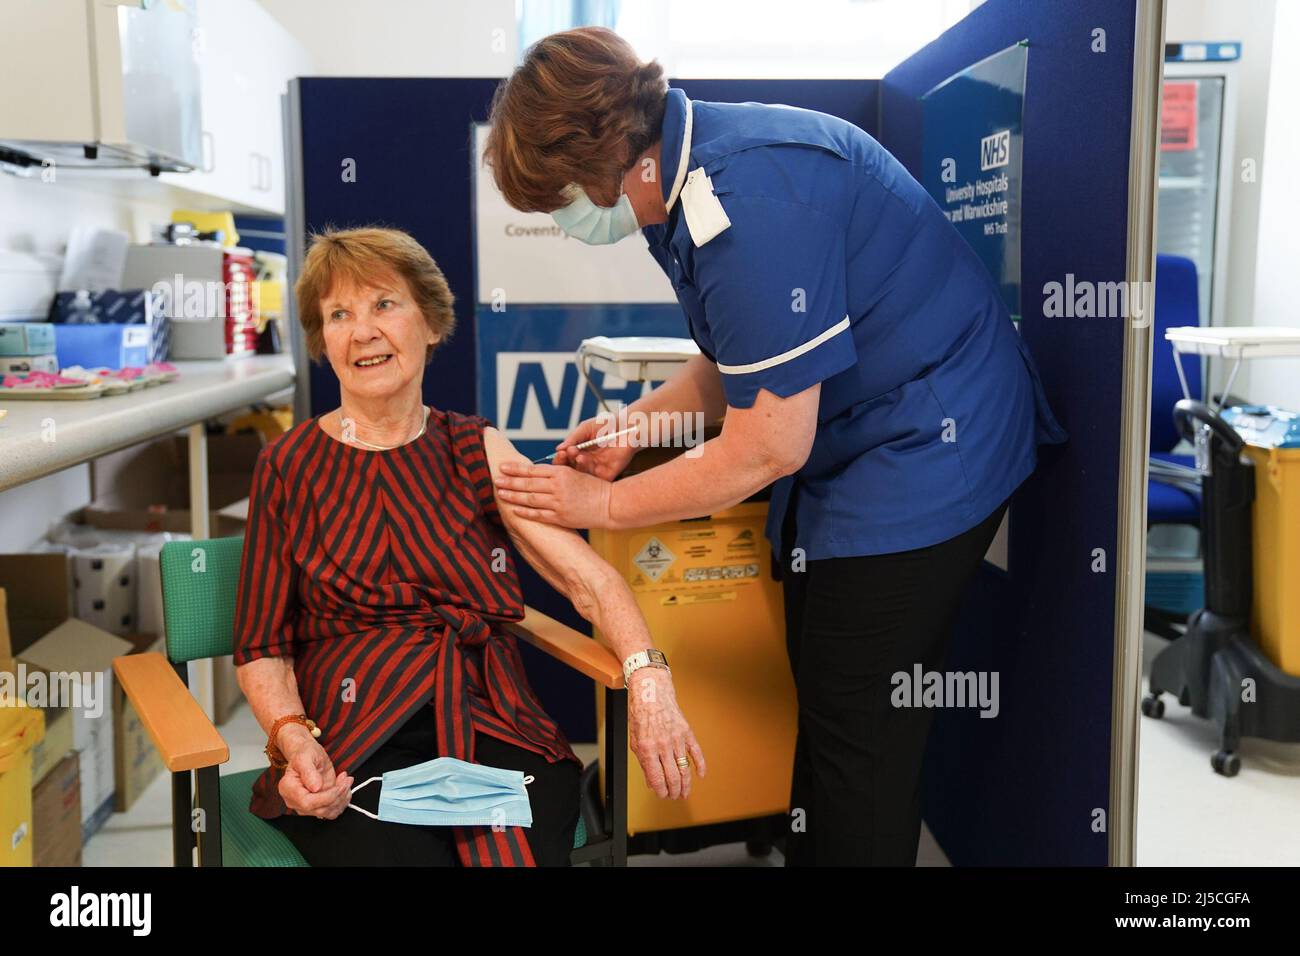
top-left (113, 652), bottom-right (230, 774)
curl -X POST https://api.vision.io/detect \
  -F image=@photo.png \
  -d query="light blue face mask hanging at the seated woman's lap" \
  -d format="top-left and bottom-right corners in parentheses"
top-left (348, 757), bottom-right (533, 827)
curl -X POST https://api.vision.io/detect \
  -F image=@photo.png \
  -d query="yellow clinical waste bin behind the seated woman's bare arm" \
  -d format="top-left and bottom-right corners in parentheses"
top-left (590, 501), bottom-right (797, 835)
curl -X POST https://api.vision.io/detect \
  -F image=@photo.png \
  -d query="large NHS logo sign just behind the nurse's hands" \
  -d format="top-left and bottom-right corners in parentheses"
top-left (489, 351), bottom-right (659, 442)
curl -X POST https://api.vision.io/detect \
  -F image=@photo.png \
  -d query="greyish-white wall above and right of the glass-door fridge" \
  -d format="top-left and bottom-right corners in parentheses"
top-left (1165, 0), bottom-right (1279, 395)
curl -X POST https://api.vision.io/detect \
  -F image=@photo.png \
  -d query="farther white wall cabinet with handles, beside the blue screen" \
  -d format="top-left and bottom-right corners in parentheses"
top-left (161, 0), bottom-right (311, 215)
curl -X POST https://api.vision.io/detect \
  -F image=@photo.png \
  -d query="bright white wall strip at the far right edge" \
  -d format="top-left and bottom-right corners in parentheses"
top-left (1249, 0), bottom-right (1300, 410)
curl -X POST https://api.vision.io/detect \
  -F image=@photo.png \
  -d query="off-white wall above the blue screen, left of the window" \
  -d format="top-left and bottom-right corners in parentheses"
top-left (261, 0), bottom-right (516, 77)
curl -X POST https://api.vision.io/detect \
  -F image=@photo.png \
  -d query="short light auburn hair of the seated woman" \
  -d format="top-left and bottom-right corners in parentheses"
top-left (294, 226), bottom-right (456, 364)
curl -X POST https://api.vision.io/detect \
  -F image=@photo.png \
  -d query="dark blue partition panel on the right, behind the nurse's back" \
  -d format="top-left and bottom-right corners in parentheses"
top-left (879, 0), bottom-right (1136, 865)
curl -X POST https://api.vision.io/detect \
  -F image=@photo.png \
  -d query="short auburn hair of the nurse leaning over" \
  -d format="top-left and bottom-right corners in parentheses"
top-left (485, 26), bottom-right (668, 212)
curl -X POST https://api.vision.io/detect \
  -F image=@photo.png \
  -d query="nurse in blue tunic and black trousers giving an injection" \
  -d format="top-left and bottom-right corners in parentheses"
top-left (488, 27), bottom-right (1065, 866)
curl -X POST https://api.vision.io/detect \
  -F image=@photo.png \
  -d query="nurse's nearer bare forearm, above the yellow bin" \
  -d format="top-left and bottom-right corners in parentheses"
top-left (610, 436), bottom-right (780, 528)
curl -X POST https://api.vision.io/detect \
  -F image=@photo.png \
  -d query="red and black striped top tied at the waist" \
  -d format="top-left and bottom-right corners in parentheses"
top-left (234, 410), bottom-right (581, 866)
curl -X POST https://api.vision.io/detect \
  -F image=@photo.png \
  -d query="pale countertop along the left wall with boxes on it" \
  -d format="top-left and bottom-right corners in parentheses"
top-left (0, 354), bottom-right (294, 490)
